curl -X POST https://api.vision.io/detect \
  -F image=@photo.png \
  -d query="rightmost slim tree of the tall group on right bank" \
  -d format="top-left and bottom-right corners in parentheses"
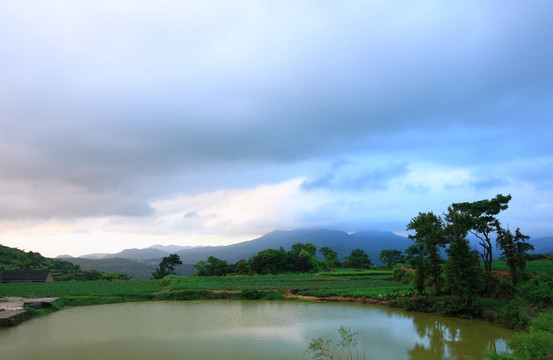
top-left (496, 221), bottom-right (534, 286)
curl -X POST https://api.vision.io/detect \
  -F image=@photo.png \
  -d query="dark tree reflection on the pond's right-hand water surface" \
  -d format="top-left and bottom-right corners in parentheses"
top-left (408, 314), bottom-right (502, 360)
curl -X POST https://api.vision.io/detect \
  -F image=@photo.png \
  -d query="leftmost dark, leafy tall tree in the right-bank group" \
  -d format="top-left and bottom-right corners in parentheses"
top-left (407, 212), bottom-right (447, 294)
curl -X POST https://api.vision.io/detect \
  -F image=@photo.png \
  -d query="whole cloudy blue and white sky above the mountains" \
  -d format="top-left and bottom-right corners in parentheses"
top-left (0, 0), bottom-right (553, 257)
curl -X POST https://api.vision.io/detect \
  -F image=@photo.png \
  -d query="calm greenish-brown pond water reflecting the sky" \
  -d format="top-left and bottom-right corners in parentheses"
top-left (0, 301), bottom-right (513, 360)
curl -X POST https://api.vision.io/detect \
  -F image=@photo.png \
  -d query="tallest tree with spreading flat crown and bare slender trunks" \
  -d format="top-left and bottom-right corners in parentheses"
top-left (451, 194), bottom-right (511, 272)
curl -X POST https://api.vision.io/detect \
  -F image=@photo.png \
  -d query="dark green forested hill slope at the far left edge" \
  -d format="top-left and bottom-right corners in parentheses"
top-left (0, 245), bottom-right (128, 281)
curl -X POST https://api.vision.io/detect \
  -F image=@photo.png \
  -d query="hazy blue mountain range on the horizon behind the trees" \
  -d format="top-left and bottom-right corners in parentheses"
top-left (63, 229), bottom-right (553, 279)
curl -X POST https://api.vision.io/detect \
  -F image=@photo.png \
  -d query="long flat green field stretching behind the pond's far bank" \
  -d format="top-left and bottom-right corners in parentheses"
top-left (0, 271), bottom-right (412, 305)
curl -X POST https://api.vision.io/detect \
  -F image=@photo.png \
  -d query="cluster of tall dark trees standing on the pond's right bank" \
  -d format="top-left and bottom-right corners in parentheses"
top-left (407, 195), bottom-right (533, 316)
